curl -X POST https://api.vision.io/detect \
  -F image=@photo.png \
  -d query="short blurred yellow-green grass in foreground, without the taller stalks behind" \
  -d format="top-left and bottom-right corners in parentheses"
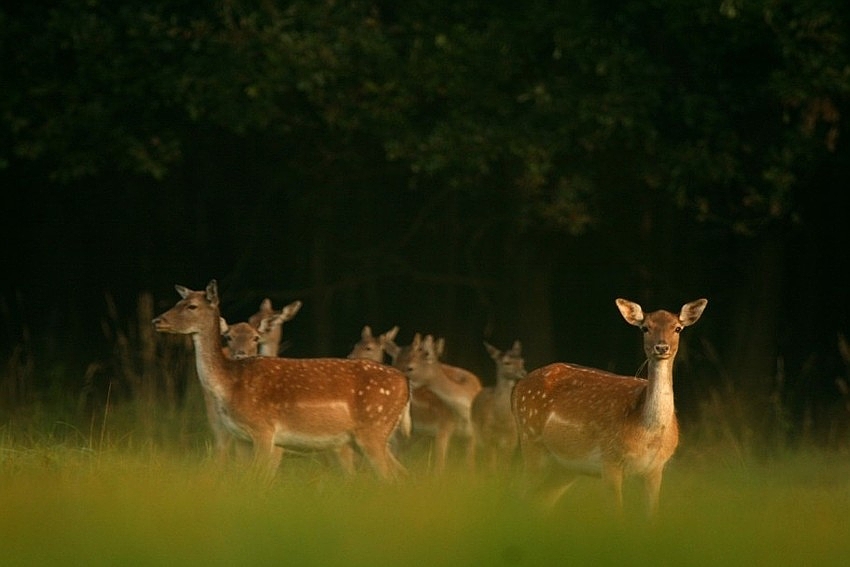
top-left (0, 406), bottom-right (850, 566)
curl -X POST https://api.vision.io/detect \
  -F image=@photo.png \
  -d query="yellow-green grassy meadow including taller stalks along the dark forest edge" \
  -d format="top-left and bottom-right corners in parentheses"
top-left (0, 297), bottom-right (850, 567)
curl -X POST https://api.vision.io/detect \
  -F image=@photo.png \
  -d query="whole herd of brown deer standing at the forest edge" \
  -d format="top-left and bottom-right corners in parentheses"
top-left (153, 280), bottom-right (707, 516)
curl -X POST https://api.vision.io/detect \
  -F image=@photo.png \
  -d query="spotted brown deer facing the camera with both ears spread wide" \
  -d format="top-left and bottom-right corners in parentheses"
top-left (511, 299), bottom-right (708, 517)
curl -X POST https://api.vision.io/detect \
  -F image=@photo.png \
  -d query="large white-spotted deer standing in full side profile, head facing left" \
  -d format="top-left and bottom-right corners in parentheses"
top-left (153, 280), bottom-right (409, 480)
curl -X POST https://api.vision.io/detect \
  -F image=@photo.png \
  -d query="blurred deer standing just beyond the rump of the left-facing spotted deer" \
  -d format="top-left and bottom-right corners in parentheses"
top-left (394, 333), bottom-right (481, 473)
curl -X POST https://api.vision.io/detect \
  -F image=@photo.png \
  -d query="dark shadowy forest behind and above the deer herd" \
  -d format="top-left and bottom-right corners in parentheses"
top-left (0, 0), bottom-right (850, 452)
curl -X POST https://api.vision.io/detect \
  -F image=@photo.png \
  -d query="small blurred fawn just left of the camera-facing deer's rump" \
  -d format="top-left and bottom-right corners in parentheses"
top-left (470, 341), bottom-right (526, 472)
